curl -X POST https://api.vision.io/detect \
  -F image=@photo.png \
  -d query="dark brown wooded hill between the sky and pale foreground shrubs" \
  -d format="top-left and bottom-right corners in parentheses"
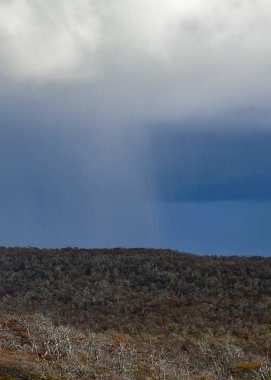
top-left (0, 247), bottom-right (271, 379)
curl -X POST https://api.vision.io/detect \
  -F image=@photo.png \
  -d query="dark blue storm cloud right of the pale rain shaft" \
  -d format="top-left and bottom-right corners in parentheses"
top-left (152, 128), bottom-right (271, 201)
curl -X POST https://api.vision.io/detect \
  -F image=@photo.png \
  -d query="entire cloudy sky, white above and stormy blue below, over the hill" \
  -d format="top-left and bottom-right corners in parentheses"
top-left (0, 0), bottom-right (271, 256)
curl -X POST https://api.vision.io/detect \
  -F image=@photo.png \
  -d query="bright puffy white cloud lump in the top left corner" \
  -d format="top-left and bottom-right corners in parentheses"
top-left (0, 0), bottom-right (100, 81)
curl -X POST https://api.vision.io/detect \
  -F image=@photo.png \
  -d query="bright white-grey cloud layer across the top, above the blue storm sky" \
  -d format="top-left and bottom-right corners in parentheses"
top-left (0, 0), bottom-right (271, 120)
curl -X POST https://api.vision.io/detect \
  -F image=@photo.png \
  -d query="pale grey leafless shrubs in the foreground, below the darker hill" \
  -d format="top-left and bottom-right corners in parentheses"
top-left (0, 314), bottom-right (271, 380)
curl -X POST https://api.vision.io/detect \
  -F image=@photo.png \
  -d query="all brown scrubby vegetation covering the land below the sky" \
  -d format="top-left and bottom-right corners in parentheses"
top-left (0, 247), bottom-right (271, 380)
